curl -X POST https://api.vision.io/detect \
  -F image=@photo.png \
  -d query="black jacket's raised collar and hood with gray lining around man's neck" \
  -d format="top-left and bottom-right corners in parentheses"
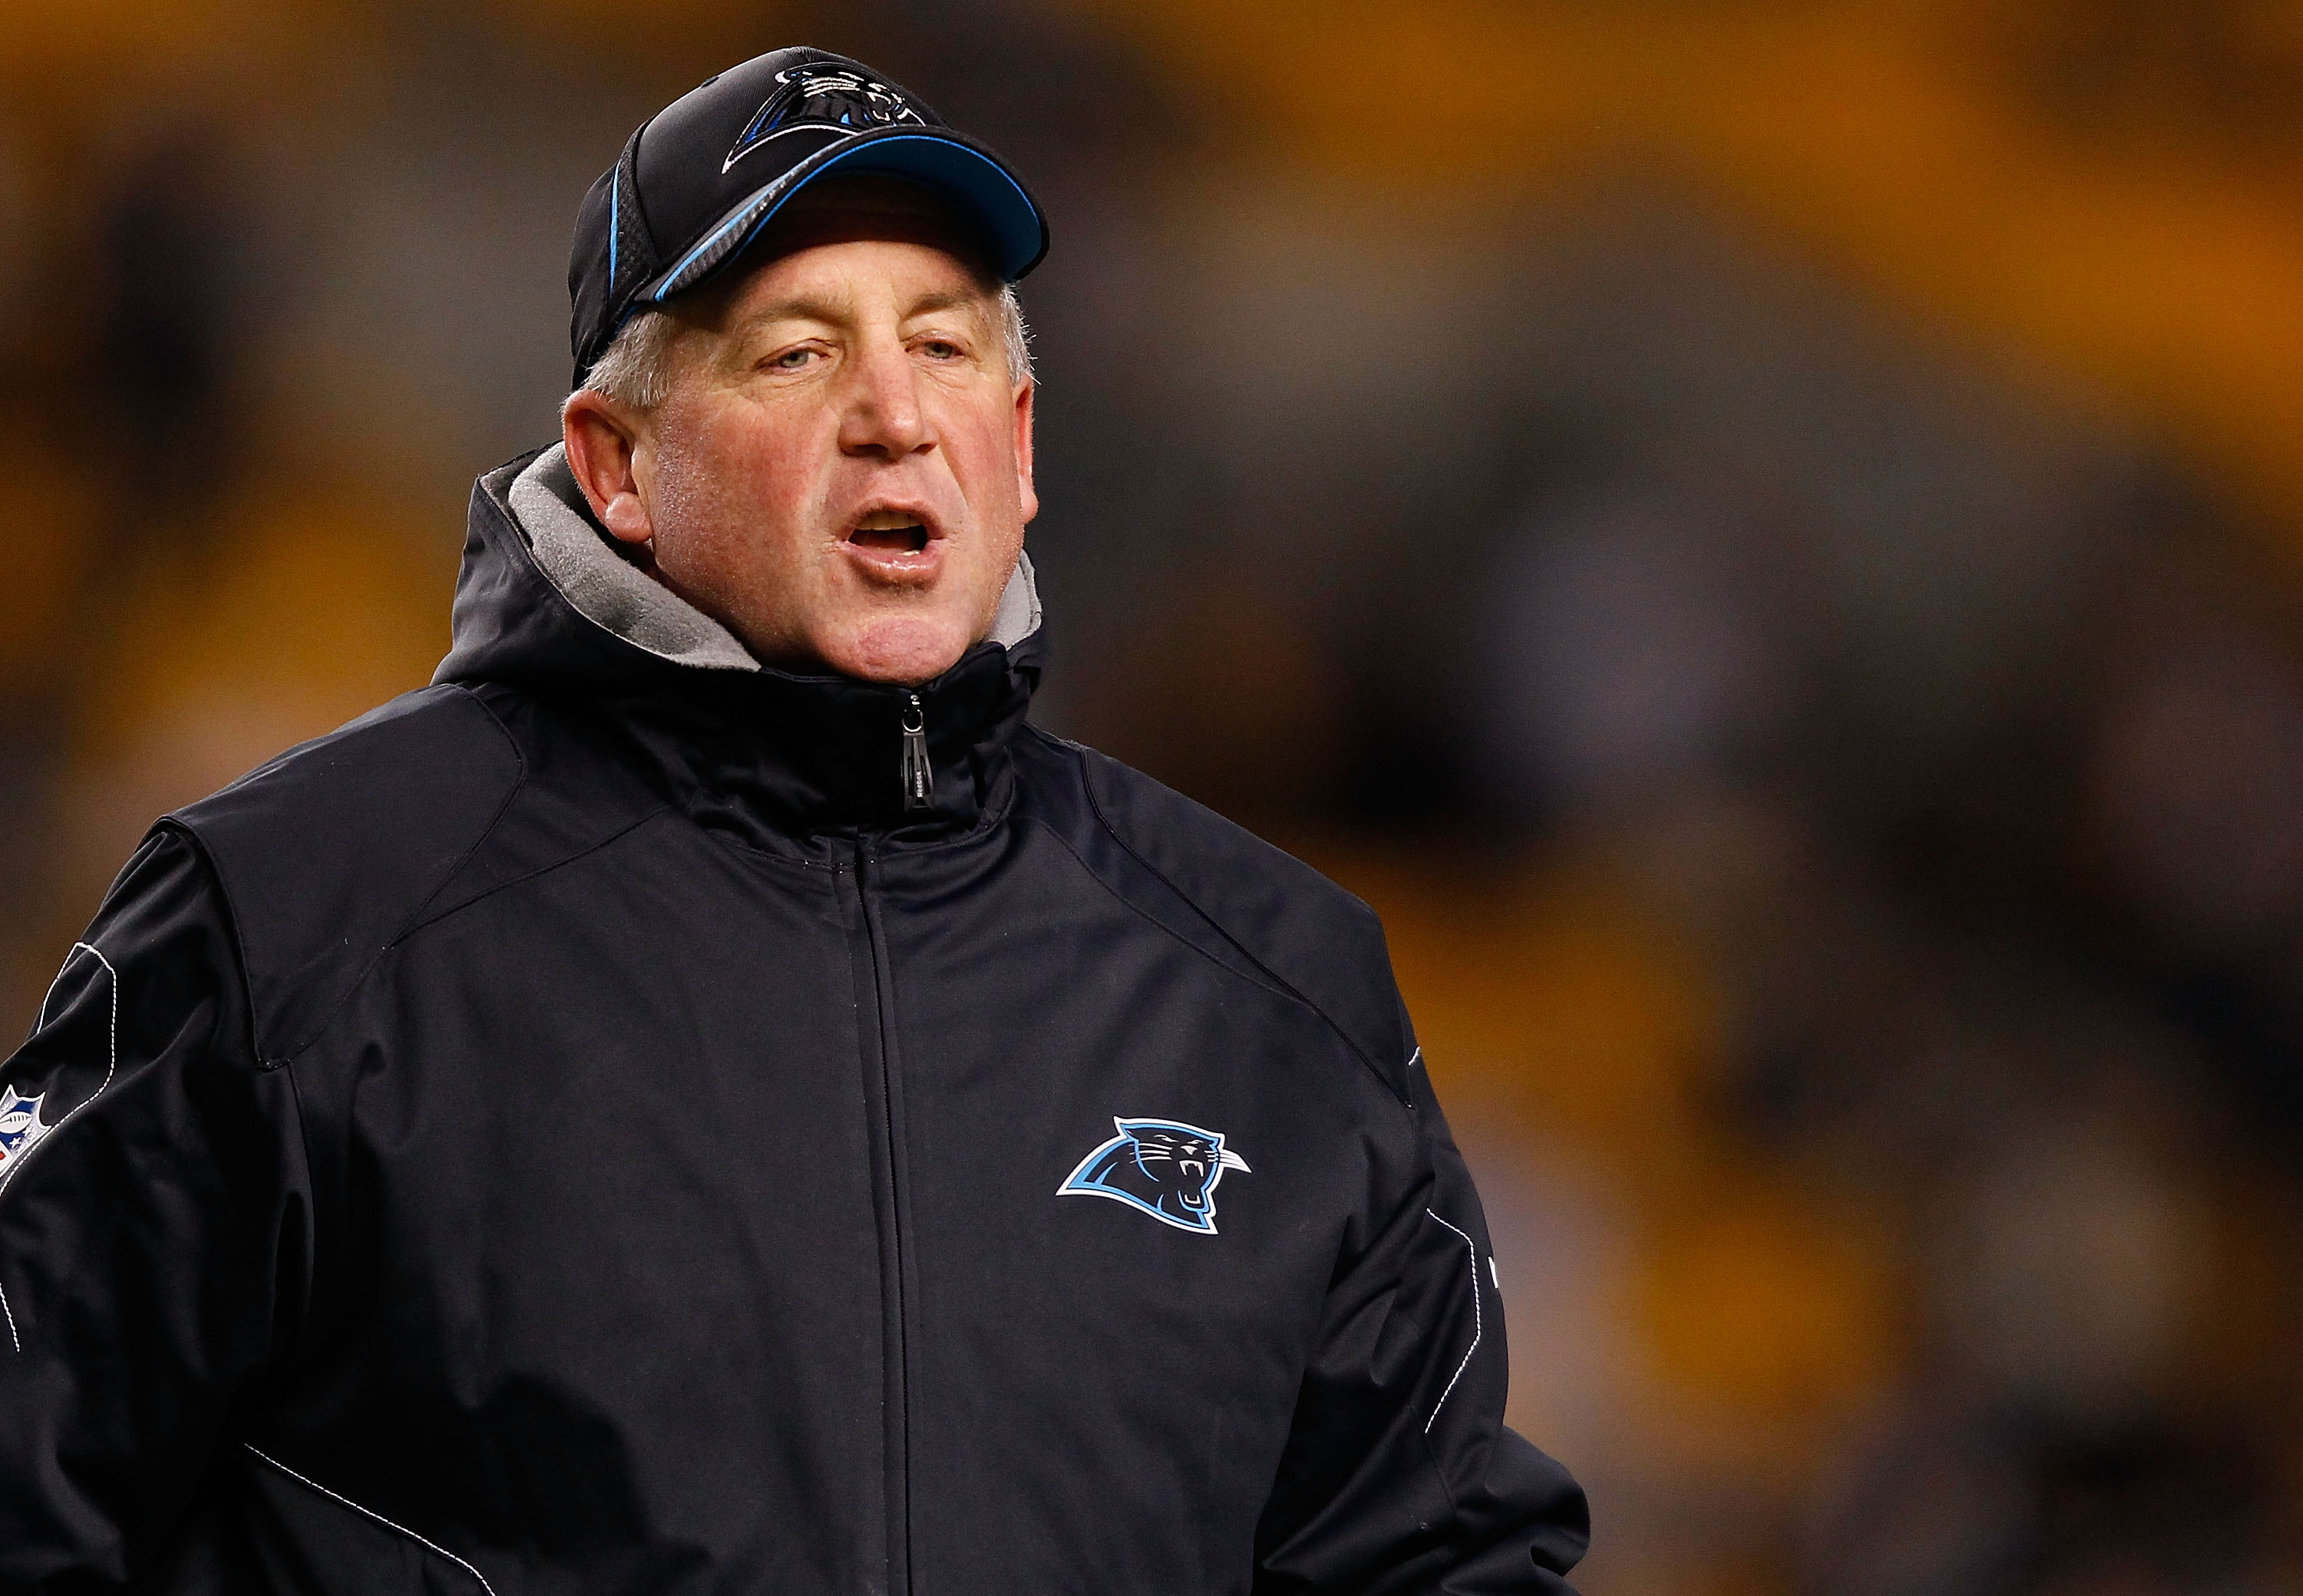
top-left (433, 444), bottom-right (1043, 831)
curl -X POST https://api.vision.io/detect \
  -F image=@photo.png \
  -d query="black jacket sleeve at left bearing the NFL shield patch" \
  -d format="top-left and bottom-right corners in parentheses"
top-left (0, 829), bottom-right (306, 1591)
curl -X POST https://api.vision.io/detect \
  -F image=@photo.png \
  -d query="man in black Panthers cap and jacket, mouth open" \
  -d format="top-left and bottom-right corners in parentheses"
top-left (0, 51), bottom-right (1584, 1596)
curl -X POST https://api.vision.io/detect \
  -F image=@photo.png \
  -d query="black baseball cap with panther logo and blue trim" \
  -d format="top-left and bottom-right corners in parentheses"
top-left (569, 46), bottom-right (1048, 387)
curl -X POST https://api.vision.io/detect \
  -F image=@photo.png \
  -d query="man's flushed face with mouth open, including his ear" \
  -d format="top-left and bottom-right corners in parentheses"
top-left (569, 189), bottom-right (1039, 684)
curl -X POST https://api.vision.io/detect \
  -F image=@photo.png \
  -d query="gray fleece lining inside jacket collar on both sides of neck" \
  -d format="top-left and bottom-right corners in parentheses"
top-left (509, 444), bottom-right (1041, 670)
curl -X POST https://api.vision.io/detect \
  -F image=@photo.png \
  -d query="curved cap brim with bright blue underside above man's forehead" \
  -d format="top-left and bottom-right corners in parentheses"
top-left (633, 127), bottom-right (1048, 306)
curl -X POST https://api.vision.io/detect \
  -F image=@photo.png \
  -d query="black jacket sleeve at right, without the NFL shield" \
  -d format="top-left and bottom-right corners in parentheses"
top-left (1255, 1027), bottom-right (1589, 1596)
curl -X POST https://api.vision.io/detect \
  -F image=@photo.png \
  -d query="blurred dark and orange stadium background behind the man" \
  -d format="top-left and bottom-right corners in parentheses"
top-left (0, 0), bottom-right (2303, 1596)
